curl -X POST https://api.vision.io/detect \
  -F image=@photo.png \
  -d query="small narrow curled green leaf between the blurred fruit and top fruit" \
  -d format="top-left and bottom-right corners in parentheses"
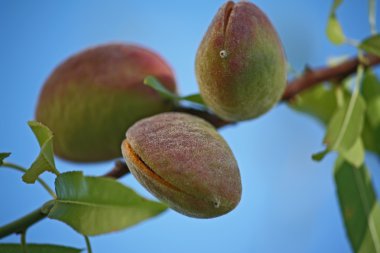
top-left (144, 76), bottom-right (206, 106)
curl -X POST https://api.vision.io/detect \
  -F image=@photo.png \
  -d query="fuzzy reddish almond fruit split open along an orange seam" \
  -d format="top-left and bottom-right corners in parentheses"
top-left (122, 112), bottom-right (242, 218)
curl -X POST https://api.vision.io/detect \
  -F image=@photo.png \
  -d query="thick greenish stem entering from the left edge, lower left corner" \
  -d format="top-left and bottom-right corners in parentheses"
top-left (0, 201), bottom-right (53, 239)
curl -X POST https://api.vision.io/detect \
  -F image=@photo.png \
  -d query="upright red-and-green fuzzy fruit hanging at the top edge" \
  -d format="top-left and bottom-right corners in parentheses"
top-left (195, 1), bottom-right (286, 121)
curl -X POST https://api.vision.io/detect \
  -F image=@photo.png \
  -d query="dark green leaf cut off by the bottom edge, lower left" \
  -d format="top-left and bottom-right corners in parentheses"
top-left (0, 243), bottom-right (82, 253)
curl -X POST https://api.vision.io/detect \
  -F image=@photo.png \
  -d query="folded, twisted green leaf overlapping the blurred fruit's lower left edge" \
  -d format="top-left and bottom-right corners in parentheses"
top-left (22, 121), bottom-right (59, 184)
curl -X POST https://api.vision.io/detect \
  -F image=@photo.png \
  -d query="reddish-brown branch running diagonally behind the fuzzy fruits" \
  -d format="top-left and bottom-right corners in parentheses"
top-left (104, 55), bottom-right (380, 178)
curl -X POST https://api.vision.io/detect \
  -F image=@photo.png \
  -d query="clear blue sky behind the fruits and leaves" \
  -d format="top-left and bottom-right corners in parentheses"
top-left (0, 0), bottom-right (380, 253)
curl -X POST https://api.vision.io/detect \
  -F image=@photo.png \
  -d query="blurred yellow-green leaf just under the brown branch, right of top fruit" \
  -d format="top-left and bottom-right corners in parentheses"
top-left (288, 85), bottom-right (337, 125)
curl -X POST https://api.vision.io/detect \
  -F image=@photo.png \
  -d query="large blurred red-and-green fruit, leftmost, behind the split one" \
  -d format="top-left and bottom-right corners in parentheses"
top-left (36, 44), bottom-right (176, 162)
